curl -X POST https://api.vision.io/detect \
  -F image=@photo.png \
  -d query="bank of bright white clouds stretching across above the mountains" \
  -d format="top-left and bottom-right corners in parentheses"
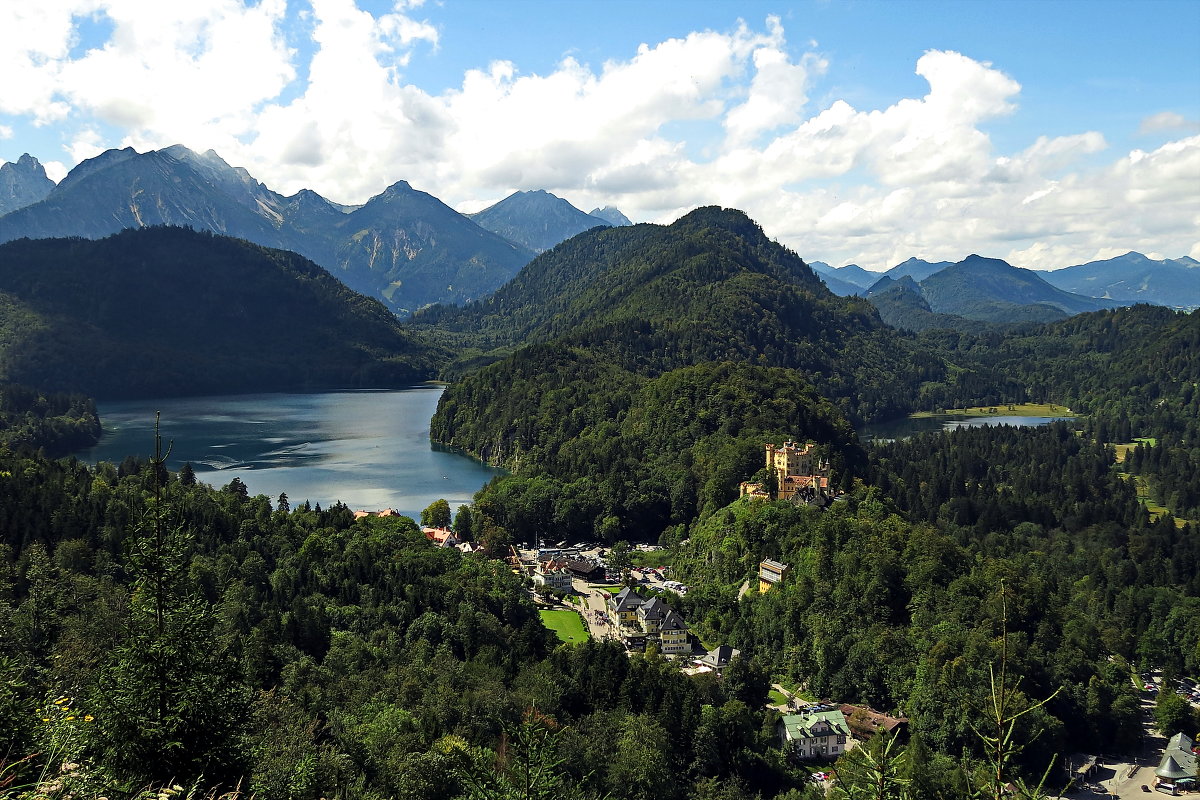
top-left (0, 0), bottom-right (1200, 269)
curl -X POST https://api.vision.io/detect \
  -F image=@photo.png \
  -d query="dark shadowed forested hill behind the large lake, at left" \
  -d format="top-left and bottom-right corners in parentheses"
top-left (0, 228), bottom-right (444, 398)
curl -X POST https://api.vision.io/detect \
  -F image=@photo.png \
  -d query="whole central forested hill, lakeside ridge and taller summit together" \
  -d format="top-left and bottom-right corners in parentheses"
top-left (425, 207), bottom-right (943, 540)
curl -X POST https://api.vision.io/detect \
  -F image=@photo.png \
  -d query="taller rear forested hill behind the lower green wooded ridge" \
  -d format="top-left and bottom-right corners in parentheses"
top-left (414, 207), bottom-right (943, 424)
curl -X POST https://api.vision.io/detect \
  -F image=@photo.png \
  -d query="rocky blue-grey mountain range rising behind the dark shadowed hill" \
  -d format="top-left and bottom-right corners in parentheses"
top-left (0, 145), bottom-right (628, 315)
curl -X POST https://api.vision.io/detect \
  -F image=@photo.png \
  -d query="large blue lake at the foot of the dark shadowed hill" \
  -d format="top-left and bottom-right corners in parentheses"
top-left (78, 386), bottom-right (500, 518)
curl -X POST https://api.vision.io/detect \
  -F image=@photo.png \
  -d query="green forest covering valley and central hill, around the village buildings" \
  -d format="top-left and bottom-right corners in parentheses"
top-left (0, 214), bottom-right (1200, 800)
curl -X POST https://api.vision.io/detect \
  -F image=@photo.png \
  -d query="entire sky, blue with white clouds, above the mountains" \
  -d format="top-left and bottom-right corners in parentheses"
top-left (0, 0), bottom-right (1200, 270)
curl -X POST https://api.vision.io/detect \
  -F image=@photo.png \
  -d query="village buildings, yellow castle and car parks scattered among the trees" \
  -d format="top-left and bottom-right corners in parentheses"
top-left (367, 441), bottom-right (1200, 786)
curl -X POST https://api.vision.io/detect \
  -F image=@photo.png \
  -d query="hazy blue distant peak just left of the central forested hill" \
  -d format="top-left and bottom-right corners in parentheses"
top-left (467, 190), bottom-right (628, 253)
